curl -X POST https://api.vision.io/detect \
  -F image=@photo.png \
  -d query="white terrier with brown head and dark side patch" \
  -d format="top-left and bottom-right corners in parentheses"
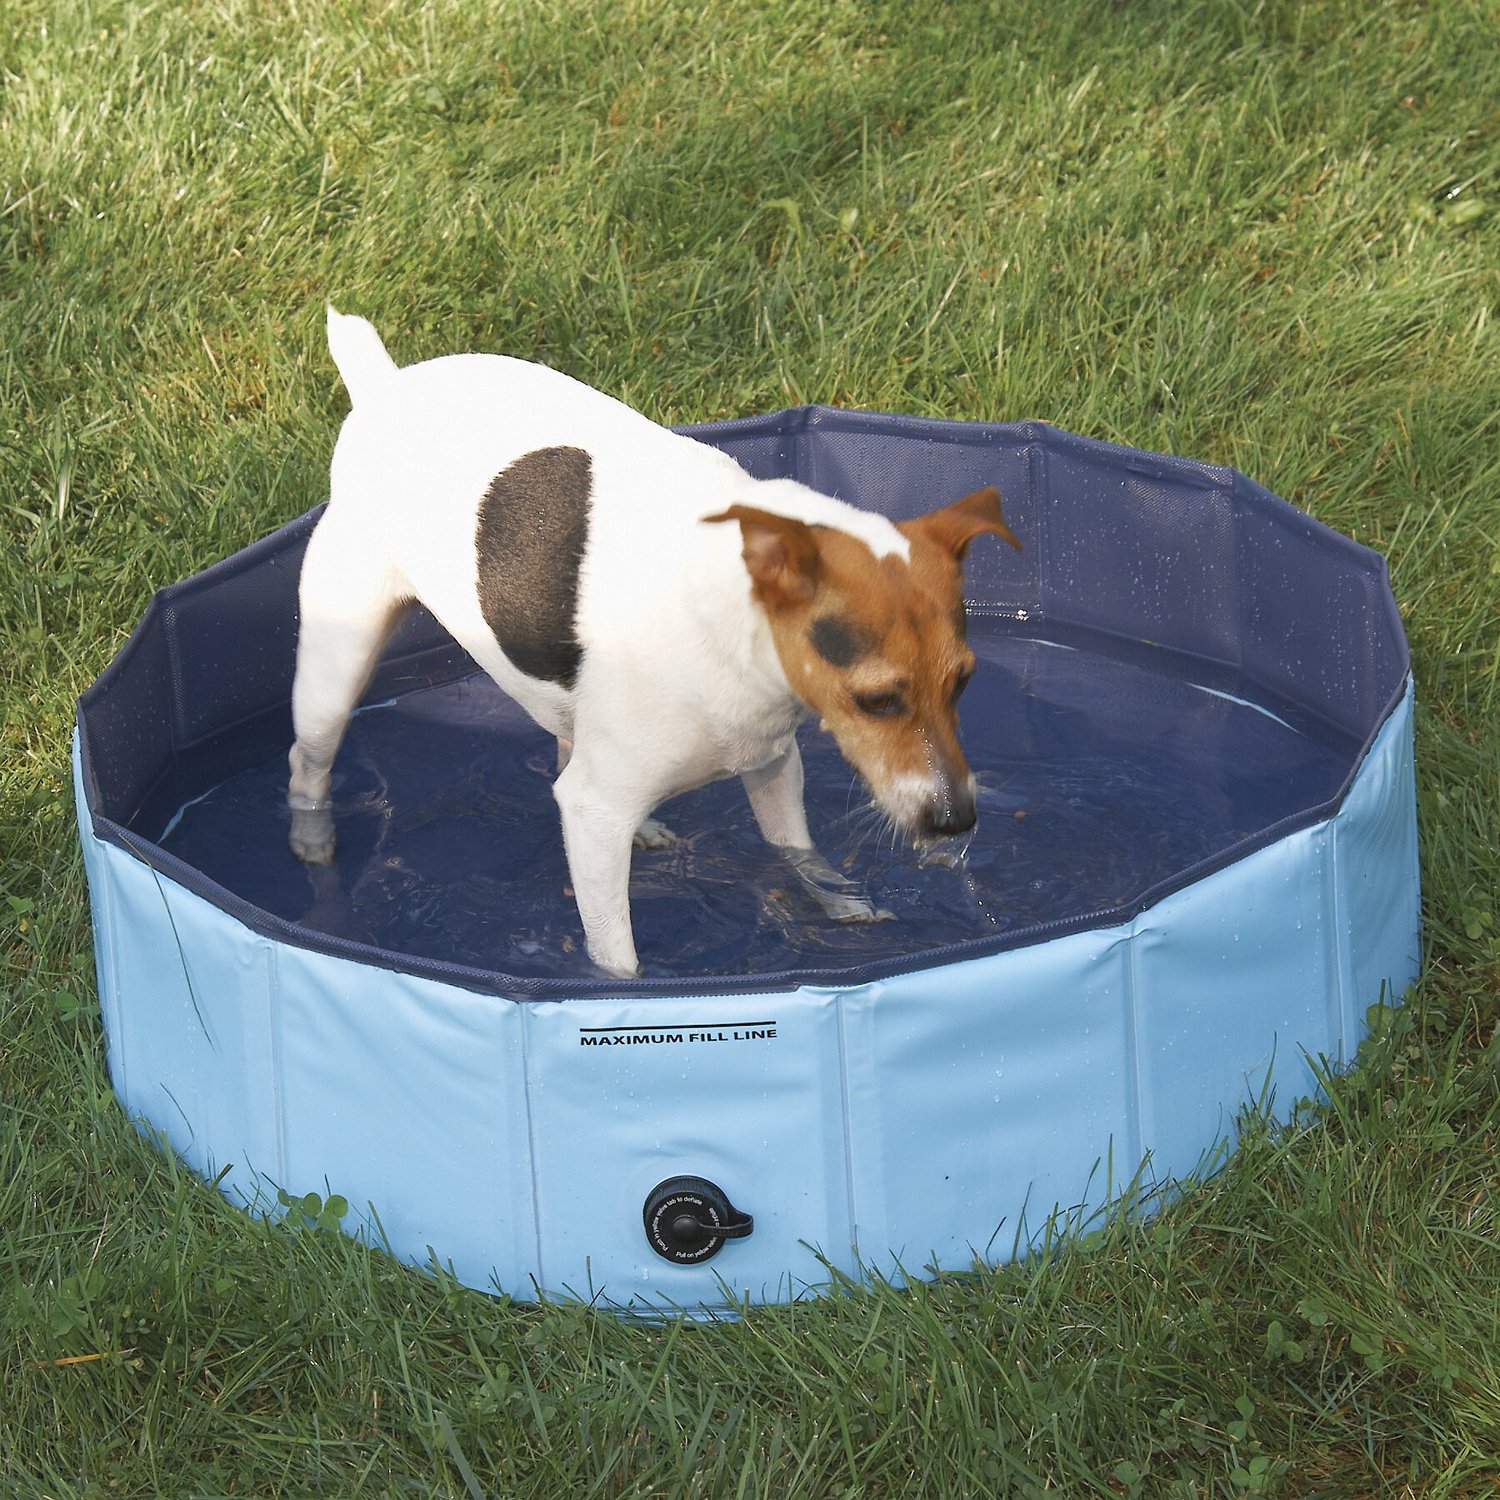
top-left (287, 306), bottom-right (1020, 978)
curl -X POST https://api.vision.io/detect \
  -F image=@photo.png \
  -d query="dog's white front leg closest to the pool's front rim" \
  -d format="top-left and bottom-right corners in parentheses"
top-left (552, 756), bottom-right (645, 978)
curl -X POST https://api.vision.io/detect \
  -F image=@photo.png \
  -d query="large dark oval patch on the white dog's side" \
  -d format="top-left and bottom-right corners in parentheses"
top-left (474, 449), bottom-right (593, 687)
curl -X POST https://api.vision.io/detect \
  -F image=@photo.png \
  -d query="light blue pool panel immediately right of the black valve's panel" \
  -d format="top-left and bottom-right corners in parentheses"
top-left (845, 930), bottom-right (1137, 1277)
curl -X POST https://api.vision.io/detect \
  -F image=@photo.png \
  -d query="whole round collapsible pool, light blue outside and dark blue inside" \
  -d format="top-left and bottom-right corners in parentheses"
top-left (75, 408), bottom-right (1419, 1313)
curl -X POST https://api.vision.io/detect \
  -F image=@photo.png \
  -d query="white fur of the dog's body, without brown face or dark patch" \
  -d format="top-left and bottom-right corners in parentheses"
top-left (288, 308), bottom-right (909, 975)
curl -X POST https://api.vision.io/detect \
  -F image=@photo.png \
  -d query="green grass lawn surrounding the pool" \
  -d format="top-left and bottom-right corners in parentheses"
top-left (0, 0), bottom-right (1500, 1497)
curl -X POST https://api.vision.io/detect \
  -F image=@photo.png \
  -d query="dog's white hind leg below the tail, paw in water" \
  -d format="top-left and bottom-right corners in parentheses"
top-left (287, 512), bottom-right (410, 864)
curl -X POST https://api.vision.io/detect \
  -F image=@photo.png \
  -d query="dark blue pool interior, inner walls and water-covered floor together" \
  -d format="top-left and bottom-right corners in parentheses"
top-left (80, 408), bottom-right (1406, 995)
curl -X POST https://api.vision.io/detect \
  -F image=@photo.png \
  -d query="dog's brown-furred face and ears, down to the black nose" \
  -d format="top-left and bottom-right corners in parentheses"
top-left (704, 488), bottom-right (1020, 839)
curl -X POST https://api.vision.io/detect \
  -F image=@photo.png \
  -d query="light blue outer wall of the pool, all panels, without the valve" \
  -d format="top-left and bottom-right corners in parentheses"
top-left (75, 684), bottom-right (1419, 1310)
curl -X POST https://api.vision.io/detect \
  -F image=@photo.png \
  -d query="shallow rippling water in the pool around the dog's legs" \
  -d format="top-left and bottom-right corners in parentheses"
top-left (155, 621), bottom-right (1358, 978)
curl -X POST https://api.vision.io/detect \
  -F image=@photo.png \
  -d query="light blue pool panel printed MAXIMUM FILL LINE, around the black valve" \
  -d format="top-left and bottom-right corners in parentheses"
top-left (524, 990), bottom-right (854, 1308)
